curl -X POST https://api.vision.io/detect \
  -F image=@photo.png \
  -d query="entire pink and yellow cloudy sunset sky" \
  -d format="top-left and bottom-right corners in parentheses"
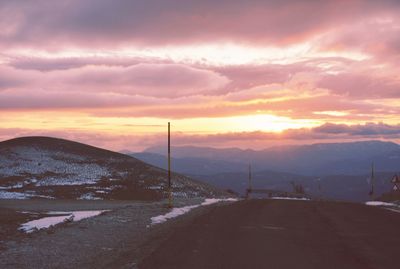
top-left (0, 0), bottom-right (400, 151)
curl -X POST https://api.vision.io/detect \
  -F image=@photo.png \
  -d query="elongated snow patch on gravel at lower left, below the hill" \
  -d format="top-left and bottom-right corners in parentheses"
top-left (19, 210), bottom-right (109, 233)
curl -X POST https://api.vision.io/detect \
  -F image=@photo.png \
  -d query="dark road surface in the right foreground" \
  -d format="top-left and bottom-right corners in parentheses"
top-left (139, 200), bottom-right (400, 269)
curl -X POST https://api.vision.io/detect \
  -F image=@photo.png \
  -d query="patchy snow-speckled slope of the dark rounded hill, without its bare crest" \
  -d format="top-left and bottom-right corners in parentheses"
top-left (0, 143), bottom-right (225, 200)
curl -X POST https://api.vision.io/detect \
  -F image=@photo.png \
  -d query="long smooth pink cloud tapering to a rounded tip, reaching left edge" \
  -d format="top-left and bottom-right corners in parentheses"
top-left (0, 64), bottom-right (229, 98)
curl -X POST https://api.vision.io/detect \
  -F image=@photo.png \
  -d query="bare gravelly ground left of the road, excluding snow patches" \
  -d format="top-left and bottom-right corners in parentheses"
top-left (0, 199), bottom-right (206, 268)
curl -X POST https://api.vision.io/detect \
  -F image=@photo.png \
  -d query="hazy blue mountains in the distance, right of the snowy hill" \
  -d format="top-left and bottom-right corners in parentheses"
top-left (130, 141), bottom-right (400, 201)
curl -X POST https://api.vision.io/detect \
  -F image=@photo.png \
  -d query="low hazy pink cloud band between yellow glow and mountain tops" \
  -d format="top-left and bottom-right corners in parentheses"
top-left (0, 123), bottom-right (400, 151)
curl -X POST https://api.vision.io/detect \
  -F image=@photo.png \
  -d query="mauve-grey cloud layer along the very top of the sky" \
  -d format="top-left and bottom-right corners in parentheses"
top-left (0, 0), bottom-right (399, 48)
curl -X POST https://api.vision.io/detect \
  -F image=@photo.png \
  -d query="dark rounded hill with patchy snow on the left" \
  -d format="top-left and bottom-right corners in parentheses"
top-left (0, 137), bottom-right (223, 199)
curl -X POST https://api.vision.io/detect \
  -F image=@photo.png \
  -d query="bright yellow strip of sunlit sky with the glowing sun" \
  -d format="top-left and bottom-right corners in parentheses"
top-left (0, 112), bottom-right (322, 133)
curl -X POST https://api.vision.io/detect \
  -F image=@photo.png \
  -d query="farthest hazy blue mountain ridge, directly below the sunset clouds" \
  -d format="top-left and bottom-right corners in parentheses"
top-left (145, 141), bottom-right (400, 176)
